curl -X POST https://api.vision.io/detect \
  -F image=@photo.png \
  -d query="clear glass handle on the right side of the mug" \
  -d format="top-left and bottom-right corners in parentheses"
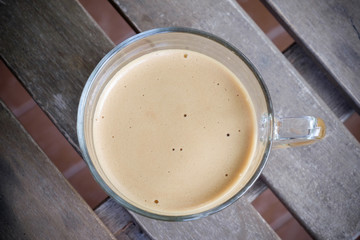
top-left (273, 116), bottom-right (326, 148)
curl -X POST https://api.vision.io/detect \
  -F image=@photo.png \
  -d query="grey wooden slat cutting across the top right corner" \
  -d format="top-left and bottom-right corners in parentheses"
top-left (262, 0), bottom-right (360, 111)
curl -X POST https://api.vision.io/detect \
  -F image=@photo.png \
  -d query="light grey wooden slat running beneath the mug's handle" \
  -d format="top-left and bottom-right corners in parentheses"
top-left (110, 0), bottom-right (360, 239)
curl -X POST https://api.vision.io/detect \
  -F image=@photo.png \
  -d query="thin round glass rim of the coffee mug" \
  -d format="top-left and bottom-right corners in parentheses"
top-left (76, 27), bottom-right (274, 221)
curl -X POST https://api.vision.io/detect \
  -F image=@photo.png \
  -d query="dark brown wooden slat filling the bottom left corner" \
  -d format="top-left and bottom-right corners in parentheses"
top-left (0, 101), bottom-right (114, 239)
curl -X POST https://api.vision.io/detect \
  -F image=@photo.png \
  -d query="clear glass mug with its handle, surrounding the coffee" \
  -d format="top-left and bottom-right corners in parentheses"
top-left (77, 28), bottom-right (325, 221)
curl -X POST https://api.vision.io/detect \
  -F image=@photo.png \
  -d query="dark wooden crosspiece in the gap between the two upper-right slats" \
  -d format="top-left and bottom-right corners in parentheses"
top-left (284, 44), bottom-right (354, 122)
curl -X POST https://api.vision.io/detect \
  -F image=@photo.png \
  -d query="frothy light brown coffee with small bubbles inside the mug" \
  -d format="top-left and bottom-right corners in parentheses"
top-left (93, 49), bottom-right (257, 215)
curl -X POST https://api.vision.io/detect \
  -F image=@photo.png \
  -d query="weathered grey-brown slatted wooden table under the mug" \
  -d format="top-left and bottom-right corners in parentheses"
top-left (0, 0), bottom-right (360, 239)
